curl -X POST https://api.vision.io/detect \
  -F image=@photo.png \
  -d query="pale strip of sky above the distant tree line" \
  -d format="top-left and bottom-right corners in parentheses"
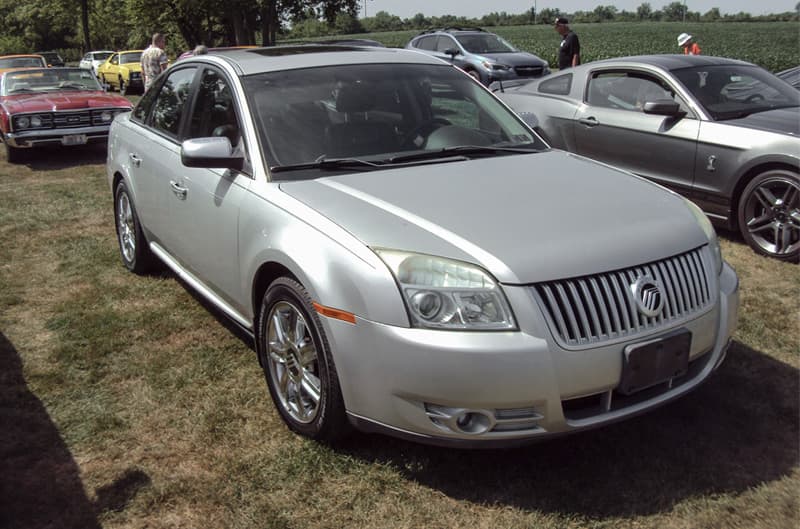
top-left (359, 0), bottom-right (797, 18)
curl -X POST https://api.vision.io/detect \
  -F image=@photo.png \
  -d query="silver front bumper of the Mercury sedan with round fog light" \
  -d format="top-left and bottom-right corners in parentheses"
top-left (323, 264), bottom-right (739, 447)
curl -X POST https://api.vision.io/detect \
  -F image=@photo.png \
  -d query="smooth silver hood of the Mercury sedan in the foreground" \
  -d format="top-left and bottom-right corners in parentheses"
top-left (280, 150), bottom-right (707, 284)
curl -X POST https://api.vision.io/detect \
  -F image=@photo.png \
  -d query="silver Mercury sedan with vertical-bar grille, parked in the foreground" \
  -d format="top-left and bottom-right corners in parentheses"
top-left (107, 46), bottom-right (739, 447)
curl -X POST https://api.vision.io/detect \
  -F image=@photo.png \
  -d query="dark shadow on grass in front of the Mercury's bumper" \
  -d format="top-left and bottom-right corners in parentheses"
top-left (338, 343), bottom-right (800, 518)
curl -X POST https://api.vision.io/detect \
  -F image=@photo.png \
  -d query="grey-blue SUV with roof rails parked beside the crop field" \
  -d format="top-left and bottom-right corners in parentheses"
top-left (406, 27), bottom-right (550, 86)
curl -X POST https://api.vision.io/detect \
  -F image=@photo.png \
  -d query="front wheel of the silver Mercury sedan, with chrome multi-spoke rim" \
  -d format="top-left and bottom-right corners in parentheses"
top-left (258, 277), bottom-right (349, 441)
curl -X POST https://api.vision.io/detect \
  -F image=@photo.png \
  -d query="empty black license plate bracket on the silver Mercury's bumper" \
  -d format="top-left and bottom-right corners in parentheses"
top-left (617, 329), bottom-right (692, 395)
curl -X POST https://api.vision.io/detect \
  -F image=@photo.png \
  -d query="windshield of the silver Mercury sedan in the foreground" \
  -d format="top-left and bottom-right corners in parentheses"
top-left (244, 64), bottom-right (546, 178)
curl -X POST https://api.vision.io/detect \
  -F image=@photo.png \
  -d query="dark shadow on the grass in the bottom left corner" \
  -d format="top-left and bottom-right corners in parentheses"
top-left (0, 332), bottom-right (100, 529)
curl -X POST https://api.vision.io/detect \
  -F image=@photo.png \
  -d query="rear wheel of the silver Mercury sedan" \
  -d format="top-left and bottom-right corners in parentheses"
top-left (114, 182), bottom-right (156, 274)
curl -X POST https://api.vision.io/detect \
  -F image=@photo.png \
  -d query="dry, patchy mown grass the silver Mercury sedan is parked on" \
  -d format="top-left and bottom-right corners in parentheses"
top-left (0, 136), bottom-right (800, 529)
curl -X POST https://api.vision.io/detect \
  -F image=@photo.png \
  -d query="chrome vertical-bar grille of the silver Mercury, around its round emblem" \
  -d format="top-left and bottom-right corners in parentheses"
top-left (531, 247), bottom-right (713, 346)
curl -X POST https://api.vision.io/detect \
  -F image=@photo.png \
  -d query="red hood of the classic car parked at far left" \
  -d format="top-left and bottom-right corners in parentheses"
top-left (3, 90), bottom-right (131, 114)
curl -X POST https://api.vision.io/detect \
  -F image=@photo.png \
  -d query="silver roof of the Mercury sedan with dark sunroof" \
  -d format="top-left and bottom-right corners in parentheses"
top-left (181, 44), bottom-right (447, 75)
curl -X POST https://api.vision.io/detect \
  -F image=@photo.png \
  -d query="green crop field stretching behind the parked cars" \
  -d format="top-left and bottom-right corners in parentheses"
top-left (322, 22), bottom-right (800, 72)
